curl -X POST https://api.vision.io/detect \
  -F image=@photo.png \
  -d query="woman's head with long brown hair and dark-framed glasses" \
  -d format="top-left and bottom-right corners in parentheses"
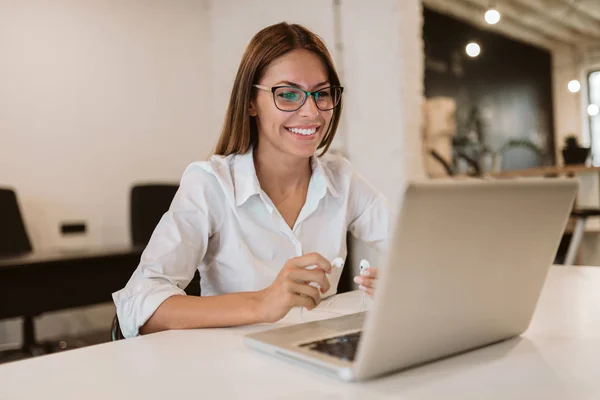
top-left (216, 24), bottom-right (343, 156)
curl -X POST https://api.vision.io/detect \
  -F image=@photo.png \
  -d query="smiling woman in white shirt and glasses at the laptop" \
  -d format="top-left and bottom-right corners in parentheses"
top-left (113, 23), bottom-right (387, 337)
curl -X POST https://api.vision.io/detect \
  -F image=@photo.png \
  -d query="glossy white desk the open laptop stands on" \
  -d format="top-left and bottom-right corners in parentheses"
top-left (0, 267), bottom-right (600, 400)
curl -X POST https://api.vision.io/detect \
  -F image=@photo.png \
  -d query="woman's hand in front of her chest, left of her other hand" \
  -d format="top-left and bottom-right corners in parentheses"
top-left (259, 253), bottom-right (331, 322)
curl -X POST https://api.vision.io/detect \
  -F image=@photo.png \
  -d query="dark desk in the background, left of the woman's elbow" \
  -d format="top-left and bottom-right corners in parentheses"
top-left (0, 247), bottom-right (143, 354)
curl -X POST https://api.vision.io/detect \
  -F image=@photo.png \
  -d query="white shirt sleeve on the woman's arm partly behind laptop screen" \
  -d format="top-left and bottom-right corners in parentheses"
top-left (348, 172), bottom-right (390, 254)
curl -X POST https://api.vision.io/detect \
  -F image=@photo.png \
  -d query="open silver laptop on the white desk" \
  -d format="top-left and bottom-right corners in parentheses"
top-left (245, 178), bottom-right (578, 380)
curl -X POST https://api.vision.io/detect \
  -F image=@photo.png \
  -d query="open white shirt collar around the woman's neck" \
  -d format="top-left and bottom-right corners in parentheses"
top-left (233, 148), bottom-right (340, 207)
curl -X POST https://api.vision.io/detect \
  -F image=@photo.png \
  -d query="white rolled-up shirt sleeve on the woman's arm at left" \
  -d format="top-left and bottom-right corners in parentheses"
top-left (112, 164), bottom-right (222, 337)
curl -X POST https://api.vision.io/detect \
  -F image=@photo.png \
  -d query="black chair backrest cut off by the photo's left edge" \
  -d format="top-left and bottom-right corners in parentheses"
top-left (0, 188), bottom-right (32, 257)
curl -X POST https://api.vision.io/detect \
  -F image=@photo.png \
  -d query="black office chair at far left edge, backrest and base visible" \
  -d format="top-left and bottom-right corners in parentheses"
top-left (0, 188), bottom-right (55, 358)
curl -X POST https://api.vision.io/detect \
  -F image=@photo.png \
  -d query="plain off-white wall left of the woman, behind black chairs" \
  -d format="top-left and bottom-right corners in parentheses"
top-left (0, 0), bottom-right (216, 249)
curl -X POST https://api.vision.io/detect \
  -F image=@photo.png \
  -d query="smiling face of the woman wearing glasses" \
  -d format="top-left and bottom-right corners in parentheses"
top-left (250, 50), bottom-right (333, 158)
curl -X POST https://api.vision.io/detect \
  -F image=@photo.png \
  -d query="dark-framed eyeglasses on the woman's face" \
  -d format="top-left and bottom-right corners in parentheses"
top-left (252, 85), bottom-right (344, 112)
